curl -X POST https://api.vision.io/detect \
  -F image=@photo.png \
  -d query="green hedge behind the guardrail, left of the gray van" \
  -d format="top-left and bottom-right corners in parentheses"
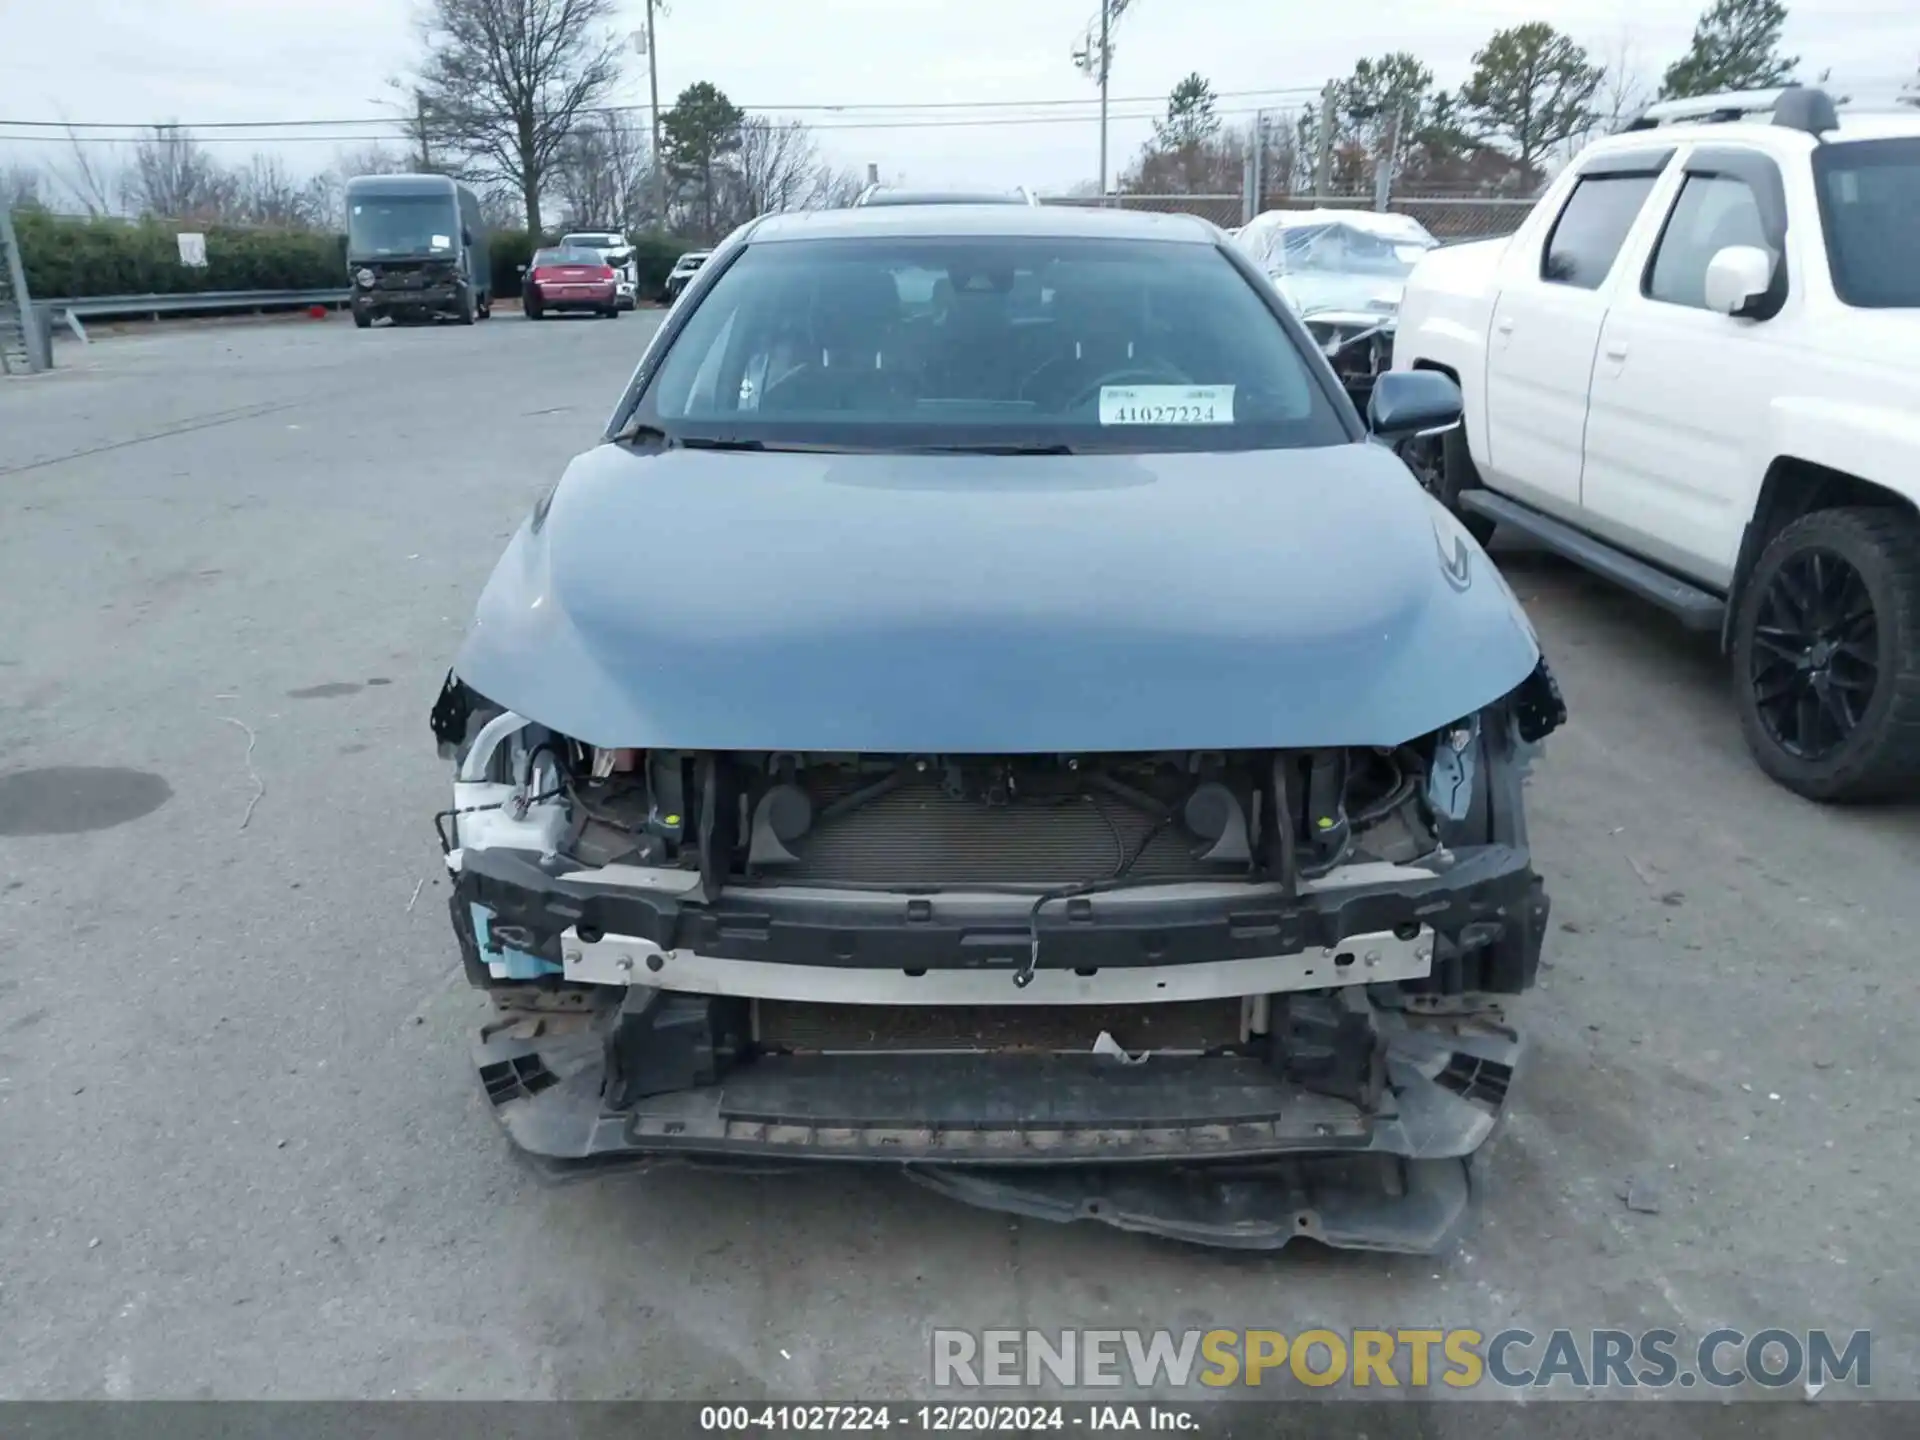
top-left (13, 209), bottom-right (348, 300)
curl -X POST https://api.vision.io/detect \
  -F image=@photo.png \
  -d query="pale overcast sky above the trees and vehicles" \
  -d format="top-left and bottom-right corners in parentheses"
top-left (0, 0), bottom-right (1920, 190)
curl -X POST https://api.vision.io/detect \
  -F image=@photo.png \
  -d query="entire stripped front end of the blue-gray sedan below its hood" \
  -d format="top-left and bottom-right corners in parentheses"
top-left (434, 664), bottom-right (1563, 1250)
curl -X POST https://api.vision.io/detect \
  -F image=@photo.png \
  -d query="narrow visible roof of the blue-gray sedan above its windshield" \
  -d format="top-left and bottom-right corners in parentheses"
top-left (747, 204), bottom-right (1219, 246)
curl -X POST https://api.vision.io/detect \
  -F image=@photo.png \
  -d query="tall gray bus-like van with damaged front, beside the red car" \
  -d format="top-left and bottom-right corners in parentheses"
top-left (348, 175), bottom-right (493, 330)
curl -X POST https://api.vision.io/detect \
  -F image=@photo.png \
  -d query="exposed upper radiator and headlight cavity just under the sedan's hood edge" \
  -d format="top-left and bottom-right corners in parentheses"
top-left (455, 726), bottom-right (1473, 895)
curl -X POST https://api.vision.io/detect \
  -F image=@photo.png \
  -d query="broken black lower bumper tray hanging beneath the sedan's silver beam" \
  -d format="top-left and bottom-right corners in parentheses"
top-left (474, 1012), bottom-right (1521, 1254)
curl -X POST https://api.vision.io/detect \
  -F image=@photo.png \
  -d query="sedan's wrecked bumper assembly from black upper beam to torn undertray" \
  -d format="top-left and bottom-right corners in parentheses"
top-left (449, 791), bottom-right (1548, 1254)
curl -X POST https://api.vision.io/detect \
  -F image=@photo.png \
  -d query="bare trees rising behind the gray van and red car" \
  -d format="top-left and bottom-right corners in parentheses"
top-left (0, 0), bottom-right (860, 238)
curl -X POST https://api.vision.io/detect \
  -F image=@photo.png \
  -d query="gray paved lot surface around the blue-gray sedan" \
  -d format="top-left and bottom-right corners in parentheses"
top-left (0, 315), bottom-right (1920, 1400)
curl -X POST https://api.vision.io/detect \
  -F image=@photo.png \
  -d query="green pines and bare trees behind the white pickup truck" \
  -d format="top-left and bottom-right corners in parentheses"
top-left (1119, 0), bottom-right (1889, 196)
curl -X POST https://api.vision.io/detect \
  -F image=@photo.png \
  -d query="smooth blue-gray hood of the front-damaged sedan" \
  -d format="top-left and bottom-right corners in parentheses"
top-left (455, 444), bottom-right (1538, 753)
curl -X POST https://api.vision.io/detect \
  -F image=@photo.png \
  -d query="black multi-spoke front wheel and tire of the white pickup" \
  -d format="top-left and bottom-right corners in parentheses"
top-left (1732, 507), bottom-right (1920, 803)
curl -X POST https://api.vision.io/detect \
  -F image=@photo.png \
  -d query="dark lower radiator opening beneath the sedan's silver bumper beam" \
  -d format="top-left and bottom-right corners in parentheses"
top-left (755, 998), bottom-right (1250, 1054)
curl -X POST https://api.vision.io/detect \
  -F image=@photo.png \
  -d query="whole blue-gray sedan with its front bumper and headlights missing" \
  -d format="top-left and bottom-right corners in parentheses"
top-left (432, 205), bottom-right (1565, 1252)
